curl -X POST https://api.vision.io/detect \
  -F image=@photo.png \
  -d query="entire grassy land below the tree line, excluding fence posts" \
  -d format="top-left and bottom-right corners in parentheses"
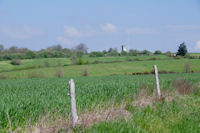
top-left (0, 55), bottom-right (200, 133)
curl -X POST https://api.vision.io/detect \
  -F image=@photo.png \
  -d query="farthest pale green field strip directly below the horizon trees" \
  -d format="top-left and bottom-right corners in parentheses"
top-left (0, 55), bottom-right (171, 72)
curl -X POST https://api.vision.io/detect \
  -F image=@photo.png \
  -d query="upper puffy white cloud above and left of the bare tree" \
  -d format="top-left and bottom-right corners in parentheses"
top-left (64, 26), bottom-right (83, 37)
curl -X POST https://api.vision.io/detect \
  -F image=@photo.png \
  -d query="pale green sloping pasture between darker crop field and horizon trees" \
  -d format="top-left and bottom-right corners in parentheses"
top-left (0, 55), bottom-right (200, 79)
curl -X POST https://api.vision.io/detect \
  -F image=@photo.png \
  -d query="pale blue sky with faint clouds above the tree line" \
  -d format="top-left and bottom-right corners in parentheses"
top-left (0, 0), bottom-right (200, 52)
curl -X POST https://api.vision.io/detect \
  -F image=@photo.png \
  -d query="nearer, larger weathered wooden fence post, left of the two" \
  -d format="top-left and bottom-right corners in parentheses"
top-left (69, 79), bottom-right (78, 127)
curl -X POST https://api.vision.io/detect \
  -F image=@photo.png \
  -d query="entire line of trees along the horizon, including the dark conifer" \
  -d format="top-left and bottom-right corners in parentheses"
top-left (0, 43), bottom-right (187, 60)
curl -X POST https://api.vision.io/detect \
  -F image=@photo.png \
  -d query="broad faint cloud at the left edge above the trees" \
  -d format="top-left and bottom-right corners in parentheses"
top-left (1, 25), bottom-right (43, 40)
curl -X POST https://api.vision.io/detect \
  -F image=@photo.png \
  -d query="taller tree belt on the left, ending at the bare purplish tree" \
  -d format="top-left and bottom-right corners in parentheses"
top-left (0, 44), bottom-right (88, 60)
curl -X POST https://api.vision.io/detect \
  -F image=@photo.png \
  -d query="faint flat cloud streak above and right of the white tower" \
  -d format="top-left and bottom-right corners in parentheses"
top-left (125, 28), bottom-right (156, 35)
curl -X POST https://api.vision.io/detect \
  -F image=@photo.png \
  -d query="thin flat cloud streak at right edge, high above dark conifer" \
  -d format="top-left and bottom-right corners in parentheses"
top-left (167, 25), bottom-right (200, 31)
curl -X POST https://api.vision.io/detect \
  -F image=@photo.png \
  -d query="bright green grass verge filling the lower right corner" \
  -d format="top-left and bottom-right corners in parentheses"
top-left (81, 96), bottom-right (200, 133)
